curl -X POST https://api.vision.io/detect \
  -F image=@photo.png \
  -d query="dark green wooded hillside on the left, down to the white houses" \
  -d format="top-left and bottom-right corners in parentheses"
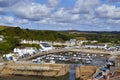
top-left (0, 26), bottom-right (71, 54)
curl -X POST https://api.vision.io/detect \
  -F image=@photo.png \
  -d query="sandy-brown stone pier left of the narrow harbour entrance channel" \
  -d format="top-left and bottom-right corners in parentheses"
top-left (0, 62), bottom-right (70, 80)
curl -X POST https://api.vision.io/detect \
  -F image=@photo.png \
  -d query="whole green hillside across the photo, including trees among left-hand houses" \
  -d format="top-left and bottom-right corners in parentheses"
top-left (0, 26), bottom-right (120, 54)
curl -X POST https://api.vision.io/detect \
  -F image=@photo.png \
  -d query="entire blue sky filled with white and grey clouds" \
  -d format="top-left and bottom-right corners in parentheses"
top-left (0, 0), bottom-right (120, 31)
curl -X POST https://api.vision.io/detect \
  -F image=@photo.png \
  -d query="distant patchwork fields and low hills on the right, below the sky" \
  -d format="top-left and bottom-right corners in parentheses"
top-left (61, 30), bottom-right (120, 45)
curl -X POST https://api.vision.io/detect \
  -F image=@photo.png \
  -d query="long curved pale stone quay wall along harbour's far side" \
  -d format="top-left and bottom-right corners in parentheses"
top-left (20, 48), bottom-right (112, 61)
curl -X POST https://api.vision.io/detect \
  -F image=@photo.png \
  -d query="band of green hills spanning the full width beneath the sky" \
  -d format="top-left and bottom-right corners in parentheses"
top-left (0, 26), bottom-right (120, 43)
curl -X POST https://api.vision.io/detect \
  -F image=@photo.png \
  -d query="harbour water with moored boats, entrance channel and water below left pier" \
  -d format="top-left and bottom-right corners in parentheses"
top-left (0, 53), bottom-right (106, 80)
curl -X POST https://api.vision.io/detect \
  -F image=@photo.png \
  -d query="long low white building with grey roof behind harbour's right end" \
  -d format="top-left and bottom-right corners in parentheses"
top-left (85, 44), bottom-right (108, 49)
